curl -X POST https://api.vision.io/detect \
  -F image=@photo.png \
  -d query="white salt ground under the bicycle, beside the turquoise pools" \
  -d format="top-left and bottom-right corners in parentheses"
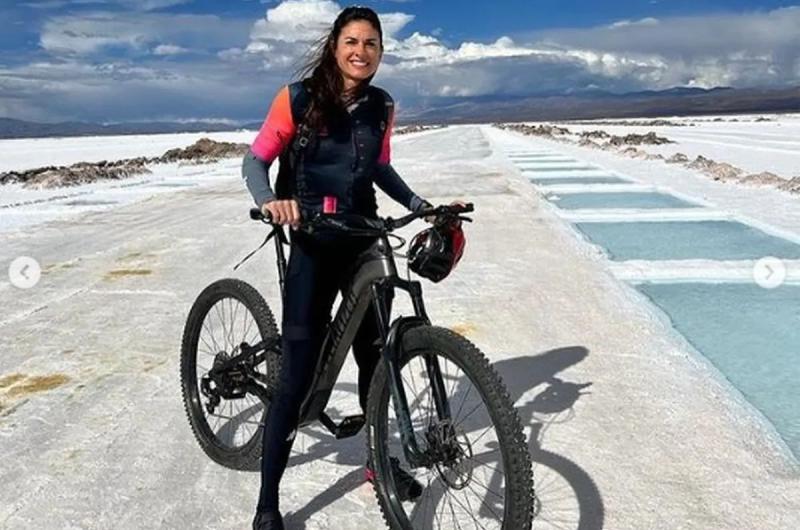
top-left (0, 126), bottom-right (800, 530)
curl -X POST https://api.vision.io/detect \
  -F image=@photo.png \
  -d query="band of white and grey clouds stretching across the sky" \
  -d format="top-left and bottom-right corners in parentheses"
top-left (6, 0), bottom-right (800, 120)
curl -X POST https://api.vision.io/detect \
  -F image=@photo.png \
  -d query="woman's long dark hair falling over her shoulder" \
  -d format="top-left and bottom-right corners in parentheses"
top-left (297, 6), bottom-right (383, 129)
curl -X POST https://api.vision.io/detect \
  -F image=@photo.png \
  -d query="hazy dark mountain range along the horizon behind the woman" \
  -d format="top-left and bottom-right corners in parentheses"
top-left (0, 87), bottom-right (800, 138)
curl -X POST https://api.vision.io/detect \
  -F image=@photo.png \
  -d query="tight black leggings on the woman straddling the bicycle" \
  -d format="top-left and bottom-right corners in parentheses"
top-left (258, 233), bottom-right (388, 511)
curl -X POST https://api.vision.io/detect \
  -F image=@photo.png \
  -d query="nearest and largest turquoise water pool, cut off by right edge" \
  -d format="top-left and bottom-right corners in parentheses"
top-left (636, 283), bottom-right (800, 458)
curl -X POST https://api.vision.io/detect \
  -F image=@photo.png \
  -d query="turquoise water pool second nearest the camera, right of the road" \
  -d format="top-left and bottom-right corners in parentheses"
top-left (575, 221), bottom-right (800, 261)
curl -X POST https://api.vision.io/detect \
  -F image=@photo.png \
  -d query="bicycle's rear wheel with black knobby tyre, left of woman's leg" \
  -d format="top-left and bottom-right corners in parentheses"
top-left (181, 279), bottom-right (280, 469)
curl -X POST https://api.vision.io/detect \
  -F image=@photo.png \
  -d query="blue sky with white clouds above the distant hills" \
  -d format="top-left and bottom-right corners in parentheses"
top-left (0, 0), bottom-right (800, 121)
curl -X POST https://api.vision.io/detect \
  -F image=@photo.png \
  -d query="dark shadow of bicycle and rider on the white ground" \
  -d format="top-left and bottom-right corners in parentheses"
top-left (285, 346), bottom-right (605, 530)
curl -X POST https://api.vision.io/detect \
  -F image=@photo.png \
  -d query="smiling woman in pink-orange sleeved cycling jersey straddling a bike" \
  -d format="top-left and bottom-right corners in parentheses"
top-left (242, 7), bottom-right (428, 530)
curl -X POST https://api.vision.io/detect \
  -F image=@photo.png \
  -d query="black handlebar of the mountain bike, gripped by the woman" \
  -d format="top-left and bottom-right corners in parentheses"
top-left (250, 203), bottom-right (475, 236)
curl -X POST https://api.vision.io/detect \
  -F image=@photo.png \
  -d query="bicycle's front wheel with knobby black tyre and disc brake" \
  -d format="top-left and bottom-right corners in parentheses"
top-left (367, 326), bottom-right (534, 530)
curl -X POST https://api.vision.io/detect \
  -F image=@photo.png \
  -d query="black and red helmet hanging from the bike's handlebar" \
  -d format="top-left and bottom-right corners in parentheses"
top-left (408, 219), bottom-right (467, 282)
